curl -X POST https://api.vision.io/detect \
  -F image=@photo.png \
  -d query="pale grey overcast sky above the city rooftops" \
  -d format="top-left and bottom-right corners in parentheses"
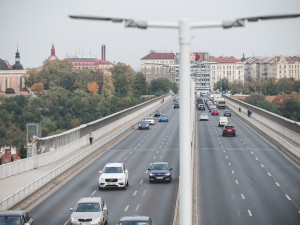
top-left (0, 0), bottom-right (300, 70)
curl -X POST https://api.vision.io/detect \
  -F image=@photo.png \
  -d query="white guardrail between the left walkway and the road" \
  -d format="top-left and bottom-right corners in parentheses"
top-left (0, 95), bottom-right (171, 211)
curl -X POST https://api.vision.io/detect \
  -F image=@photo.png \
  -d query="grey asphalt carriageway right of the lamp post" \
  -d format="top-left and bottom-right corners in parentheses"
top-left (198, 107), bottom-right (300, 224)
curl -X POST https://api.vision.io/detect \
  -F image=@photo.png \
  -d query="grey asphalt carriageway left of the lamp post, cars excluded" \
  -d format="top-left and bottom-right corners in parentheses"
top-left (30, 103), bottom-right (179, 225)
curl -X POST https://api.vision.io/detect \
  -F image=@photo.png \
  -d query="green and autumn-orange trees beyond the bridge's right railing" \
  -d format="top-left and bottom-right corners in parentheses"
top-left (215, 77), bottom-right (300, 122)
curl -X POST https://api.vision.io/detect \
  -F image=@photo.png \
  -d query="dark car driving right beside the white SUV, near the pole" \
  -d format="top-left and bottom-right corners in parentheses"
top-left (148, 162), bottom-right (173, 183)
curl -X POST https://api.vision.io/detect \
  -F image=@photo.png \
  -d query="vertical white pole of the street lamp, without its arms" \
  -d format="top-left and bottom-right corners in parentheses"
top-left (179, 19), bottom-right (192, 225)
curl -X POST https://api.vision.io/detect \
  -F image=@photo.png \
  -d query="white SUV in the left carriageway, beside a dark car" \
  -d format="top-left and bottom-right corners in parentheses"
top-left (99, 163), bottom-right (128, 190)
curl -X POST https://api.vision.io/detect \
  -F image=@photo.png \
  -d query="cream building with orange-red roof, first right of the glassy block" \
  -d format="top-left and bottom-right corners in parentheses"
top-left (210, 56), bottom-right (245, 90)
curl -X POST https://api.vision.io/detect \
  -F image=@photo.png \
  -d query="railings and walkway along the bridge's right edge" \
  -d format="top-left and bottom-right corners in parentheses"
top-left (223, 95), bottom-right (300, 158)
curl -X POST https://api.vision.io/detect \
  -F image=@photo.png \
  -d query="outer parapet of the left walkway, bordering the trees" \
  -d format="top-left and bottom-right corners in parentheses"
top-left (0, 94), bottom-right (171, 179)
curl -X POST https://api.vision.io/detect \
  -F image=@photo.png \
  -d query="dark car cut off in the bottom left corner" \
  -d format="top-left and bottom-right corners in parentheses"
top-left (0, 210), bottom-right (33, 225)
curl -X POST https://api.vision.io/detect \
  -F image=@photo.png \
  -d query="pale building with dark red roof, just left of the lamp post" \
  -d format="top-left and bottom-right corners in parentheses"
top-left (140, 51), bottom-right (175, 83)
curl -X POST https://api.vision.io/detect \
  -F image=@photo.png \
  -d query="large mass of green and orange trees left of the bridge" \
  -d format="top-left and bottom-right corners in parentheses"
top-left (0, 59), bottom-right (178, 155)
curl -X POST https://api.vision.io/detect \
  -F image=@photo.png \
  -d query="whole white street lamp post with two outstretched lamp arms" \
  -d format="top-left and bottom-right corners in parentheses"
top-left (70, 14), bottom-right (300, 225)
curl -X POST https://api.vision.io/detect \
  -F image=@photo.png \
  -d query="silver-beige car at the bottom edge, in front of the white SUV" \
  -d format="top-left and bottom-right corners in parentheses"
top-left (70, 197), bottom-right (108, 225)
